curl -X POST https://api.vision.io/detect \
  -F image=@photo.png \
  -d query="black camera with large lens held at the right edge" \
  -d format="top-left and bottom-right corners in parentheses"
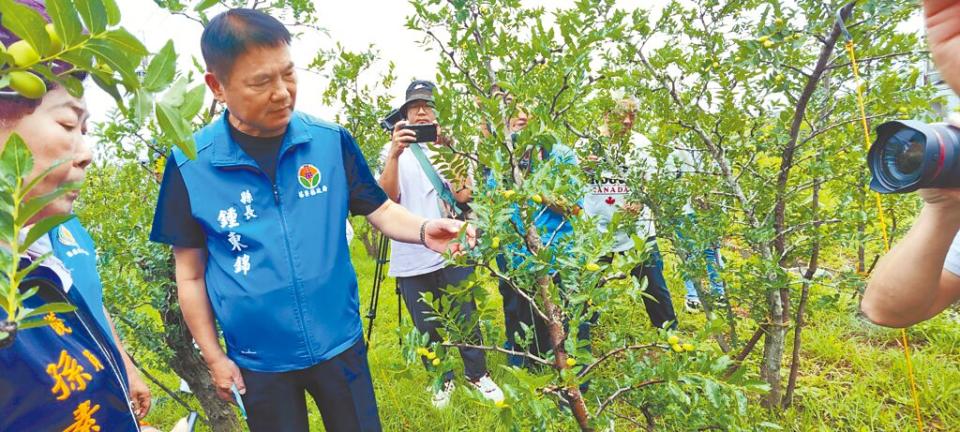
top-left (867, 120), bottom-right (960, 193)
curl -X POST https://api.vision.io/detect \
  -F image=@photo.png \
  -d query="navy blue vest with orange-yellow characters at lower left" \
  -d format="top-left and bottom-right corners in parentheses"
top-left (0, 260), bottom-right (138, 431)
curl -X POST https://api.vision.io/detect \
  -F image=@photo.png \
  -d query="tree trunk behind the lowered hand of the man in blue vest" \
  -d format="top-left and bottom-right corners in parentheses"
top-left (161, 275), bottom-right (241, 432)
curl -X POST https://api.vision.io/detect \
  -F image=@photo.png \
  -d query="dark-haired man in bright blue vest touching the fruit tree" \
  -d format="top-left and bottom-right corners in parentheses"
top-left (151, 9), bottom-right (475, 431)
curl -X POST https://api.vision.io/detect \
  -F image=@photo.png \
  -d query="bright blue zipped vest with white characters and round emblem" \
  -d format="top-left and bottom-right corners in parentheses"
top-left (173, 112), bottom-right (362, 372)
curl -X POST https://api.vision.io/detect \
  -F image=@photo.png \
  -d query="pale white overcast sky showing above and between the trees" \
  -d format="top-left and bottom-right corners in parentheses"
top-left (87, 0), bottom-right (666, 126)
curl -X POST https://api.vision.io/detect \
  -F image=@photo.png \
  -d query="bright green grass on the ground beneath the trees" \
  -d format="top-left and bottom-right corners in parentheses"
top-left (135, 242), bottom-right (960, 431)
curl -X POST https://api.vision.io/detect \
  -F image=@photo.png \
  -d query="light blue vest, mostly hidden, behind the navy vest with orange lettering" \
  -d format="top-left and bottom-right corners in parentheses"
top-left (47, 218), bottom-right (113, 343)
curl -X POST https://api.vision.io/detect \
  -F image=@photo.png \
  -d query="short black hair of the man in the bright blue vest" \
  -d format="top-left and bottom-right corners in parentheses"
top-left (200, 8), bottom-right (290, 80)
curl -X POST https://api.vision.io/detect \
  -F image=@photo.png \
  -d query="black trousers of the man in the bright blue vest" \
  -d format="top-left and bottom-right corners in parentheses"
top-left (240, 338), bottom-right (381, 432)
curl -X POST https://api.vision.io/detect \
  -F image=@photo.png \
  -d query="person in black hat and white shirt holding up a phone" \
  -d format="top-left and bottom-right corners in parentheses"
top-left (379, 80), bottom-right (504, 408)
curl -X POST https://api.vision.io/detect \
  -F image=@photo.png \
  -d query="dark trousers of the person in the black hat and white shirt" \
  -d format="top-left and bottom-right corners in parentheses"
top-left (397, 267), bottom-right (487, 381)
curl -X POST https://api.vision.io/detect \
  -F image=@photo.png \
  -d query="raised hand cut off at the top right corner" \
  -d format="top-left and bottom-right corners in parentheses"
top-left (923, 0), bottom-right (960, 93)
